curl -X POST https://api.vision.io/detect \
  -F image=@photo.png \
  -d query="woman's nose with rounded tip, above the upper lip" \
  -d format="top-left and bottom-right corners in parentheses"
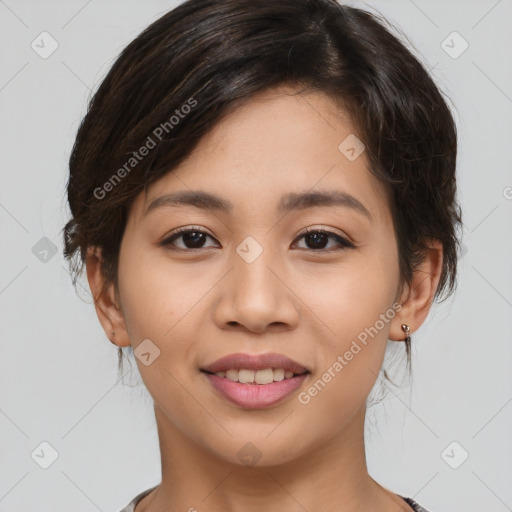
top-left (214, 245), bottom-right (300, 333)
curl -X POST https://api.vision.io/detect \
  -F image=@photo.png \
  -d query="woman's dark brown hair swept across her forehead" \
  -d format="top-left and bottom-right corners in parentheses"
top-left (63, 0), bottom-right (462, 377)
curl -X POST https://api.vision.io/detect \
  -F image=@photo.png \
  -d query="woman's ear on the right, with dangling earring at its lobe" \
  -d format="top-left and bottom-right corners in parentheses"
top-left (389, 240), bottom-right (443, 341)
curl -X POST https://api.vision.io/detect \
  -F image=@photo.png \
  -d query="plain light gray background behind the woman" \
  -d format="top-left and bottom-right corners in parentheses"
top-left (0, 0), bottom-right (512, 512)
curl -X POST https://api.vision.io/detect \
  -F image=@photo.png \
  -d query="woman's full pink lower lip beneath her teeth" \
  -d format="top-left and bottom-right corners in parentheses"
top-left (203, 372), bottom-right (309, 409)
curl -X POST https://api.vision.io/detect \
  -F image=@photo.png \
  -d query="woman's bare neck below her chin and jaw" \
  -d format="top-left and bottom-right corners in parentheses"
top-left (136, 406), bottom-right (410, 512)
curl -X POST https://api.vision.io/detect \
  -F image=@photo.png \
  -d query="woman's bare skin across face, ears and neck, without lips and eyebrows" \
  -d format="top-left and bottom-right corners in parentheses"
top-left (86, 88), bottom-right (442, 512)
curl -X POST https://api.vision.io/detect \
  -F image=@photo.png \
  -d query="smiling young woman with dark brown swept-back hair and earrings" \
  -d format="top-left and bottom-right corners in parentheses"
top-left (64, 0), bottom-right (461, 512)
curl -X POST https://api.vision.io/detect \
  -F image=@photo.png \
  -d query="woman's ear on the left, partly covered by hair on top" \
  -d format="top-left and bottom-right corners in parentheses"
top-left (85, 247), bottom-right (130, 347)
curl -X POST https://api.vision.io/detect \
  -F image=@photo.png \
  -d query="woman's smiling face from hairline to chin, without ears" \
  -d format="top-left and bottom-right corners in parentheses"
top-left (114, 89), bottom-right (400, 465)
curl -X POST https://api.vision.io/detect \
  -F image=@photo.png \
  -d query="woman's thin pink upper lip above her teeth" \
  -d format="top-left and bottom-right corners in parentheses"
top-left (202, 352), bottom-right (309, 375)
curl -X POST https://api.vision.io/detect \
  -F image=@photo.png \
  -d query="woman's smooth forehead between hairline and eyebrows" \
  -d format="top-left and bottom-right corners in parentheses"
top-left (134, 87), bottom-right (388, 223)
